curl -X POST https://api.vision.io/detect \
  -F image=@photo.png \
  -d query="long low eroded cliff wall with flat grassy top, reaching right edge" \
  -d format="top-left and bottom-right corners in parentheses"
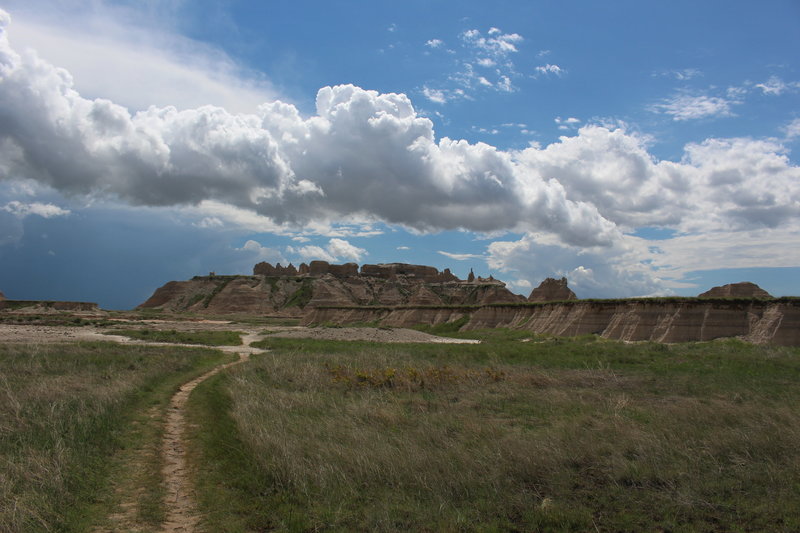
top-left (303, 299), bottom-right (800, 346)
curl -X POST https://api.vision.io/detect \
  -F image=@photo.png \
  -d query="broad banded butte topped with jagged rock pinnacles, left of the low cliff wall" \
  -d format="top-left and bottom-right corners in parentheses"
top-left (139, 261), bottom-right (525, 316)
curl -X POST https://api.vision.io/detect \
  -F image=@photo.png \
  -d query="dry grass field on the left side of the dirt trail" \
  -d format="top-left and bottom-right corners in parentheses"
top-left (0, 343), bottom-right (231, 533)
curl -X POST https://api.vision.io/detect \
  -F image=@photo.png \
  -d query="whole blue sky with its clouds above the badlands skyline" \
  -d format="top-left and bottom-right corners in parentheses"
top-left (0, 0), bottom-right (800, 309)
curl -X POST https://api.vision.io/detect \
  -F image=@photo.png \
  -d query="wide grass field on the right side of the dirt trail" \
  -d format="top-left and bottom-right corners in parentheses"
top-left (189, 330), bottom-right (800, 531)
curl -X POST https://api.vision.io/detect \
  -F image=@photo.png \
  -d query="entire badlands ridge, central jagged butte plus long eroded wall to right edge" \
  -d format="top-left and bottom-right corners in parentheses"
top-left (134, 261), bottom-right (800, 345)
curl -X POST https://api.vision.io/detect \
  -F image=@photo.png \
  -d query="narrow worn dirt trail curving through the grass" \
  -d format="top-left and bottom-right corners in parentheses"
top-left (161, 333), bottom-right (264, 533)
